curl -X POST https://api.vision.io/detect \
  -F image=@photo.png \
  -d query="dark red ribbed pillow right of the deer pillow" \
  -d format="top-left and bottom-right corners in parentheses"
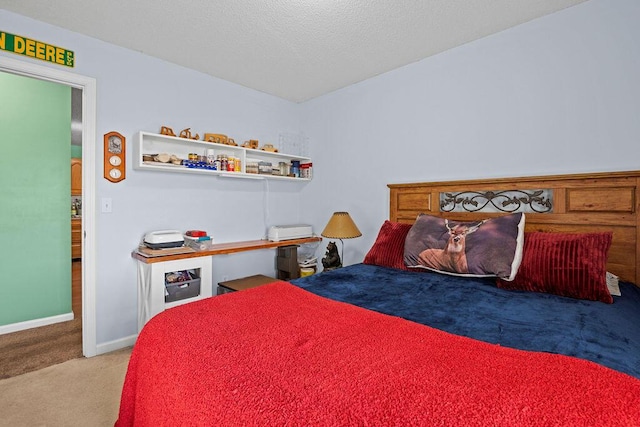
top-left (497, 232), bottom-right (613, 304)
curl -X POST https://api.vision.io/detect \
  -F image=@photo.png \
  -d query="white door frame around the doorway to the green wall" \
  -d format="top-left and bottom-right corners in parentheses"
top-left (0, 56), bottom-right (98, 357)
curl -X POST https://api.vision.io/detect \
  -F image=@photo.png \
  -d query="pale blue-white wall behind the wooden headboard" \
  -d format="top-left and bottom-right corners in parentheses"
top-left (302, 0), bottom-right (640, 264)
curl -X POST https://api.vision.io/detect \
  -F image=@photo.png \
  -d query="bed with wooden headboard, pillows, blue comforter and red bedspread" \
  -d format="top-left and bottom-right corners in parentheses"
top-left (116, 172), bottom-right (640, 426)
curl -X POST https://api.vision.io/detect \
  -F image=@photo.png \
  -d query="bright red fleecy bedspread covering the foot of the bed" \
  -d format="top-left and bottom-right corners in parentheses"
top-left (116, 282), bottom-right (640, 426)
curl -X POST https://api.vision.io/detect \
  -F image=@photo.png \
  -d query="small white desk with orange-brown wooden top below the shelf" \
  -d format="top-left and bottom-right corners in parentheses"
top-left (131, 237), bottom-right (322, 331)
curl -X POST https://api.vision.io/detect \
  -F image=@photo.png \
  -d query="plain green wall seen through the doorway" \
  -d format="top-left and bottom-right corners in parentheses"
top-left (0, 73), bottom-right (71, 325)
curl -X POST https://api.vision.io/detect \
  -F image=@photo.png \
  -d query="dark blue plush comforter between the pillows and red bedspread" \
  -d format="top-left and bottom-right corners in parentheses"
top-left (292, 264), bottom-right (640, 378)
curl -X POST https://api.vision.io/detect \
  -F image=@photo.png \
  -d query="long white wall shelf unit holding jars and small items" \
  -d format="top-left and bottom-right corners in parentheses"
top-left (133, 132), bottom-right (311, 181)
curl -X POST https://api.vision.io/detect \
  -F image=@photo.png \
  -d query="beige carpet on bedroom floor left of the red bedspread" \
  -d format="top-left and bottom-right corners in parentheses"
top-left (0, 348), bottom-right (131, 427)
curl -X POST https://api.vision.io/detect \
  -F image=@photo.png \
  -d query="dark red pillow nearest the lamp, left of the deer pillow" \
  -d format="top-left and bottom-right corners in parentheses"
top-left (363, 220), bottom-right (411, 270)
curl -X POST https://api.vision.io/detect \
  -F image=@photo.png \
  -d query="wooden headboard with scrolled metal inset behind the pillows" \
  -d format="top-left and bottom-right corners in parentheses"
top-left (388, 171), bottom-right (640, 286)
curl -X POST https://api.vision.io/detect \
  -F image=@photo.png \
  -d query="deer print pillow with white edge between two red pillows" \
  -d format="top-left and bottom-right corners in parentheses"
top-left (404, 212), bottom-right (524, 281)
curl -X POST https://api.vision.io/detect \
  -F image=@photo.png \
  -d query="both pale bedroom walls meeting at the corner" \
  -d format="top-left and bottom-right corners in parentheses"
top-left (0, 0), bottom-right (640, 350)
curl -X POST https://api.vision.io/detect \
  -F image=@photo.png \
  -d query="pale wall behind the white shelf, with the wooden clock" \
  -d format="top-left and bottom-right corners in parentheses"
top-left (0, 10), bottom-right (305, 345)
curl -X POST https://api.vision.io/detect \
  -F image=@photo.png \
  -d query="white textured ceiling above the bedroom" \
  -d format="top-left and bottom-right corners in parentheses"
top-left (0, 0), bottom-right (585, 102)
